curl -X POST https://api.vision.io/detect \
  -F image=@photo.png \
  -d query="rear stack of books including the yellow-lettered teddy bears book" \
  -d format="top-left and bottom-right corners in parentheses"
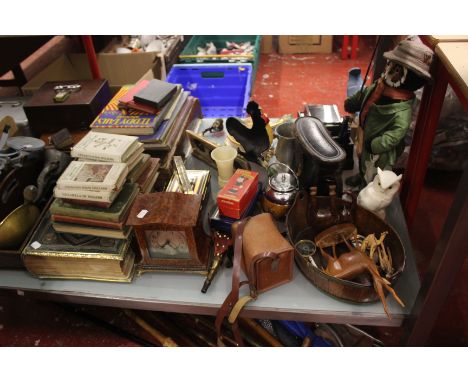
top-left (91, 80), bottom-right (201, 176)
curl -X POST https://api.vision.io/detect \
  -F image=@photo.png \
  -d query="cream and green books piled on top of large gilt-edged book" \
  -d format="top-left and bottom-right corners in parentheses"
top-left (51, 132), bottom-right (159, 239)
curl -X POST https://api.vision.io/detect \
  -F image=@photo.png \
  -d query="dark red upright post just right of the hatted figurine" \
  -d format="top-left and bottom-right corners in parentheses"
top-left (401, 56), bottom-right (448, 227)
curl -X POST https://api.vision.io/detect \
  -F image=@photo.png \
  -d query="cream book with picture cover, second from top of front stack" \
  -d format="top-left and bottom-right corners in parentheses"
top-left (56, 161), bottom-right (128, 191)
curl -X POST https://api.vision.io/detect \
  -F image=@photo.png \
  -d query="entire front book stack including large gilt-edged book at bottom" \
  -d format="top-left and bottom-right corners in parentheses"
top-left (23, 132), bottom-right (159, 282)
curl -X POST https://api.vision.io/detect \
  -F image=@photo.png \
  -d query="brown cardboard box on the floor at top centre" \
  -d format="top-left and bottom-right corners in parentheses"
top-left (278, 35), bottom-right (333, 54)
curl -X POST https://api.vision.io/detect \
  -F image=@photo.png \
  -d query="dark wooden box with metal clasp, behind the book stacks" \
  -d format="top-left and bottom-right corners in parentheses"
top-left (24, 80), bottom-right (111, 137)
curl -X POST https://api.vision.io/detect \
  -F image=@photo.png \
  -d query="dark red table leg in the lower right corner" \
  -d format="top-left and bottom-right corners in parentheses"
top-left (403, 168), bottom-right (468, 346)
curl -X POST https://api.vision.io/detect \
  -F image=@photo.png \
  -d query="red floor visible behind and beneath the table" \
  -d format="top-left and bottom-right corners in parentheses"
top-left (0, 38), bottom-right (468, 346)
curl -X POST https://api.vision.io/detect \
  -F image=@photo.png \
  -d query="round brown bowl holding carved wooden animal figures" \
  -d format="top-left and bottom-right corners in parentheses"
top-left (286, 191), bottom-right (406, 303)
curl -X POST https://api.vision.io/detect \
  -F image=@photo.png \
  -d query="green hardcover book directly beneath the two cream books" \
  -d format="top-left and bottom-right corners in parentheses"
top-left (50, 183), bottom-right (139, 222)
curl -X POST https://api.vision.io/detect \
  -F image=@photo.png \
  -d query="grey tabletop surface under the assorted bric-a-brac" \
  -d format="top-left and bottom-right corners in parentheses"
top-left (0, 131), bottom-right (420, 326)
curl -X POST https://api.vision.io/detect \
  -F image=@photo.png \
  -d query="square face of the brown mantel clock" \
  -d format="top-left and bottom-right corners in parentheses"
top-left (145, 230), bottom-right (190, 259)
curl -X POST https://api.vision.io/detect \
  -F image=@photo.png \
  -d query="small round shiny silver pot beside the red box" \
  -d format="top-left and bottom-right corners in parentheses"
top-left (261, 162), bottom-right (299, 219)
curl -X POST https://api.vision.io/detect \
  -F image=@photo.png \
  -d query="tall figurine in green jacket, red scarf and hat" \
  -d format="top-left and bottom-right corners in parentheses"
top-left (344, 36), bottom-right (433, 188)
